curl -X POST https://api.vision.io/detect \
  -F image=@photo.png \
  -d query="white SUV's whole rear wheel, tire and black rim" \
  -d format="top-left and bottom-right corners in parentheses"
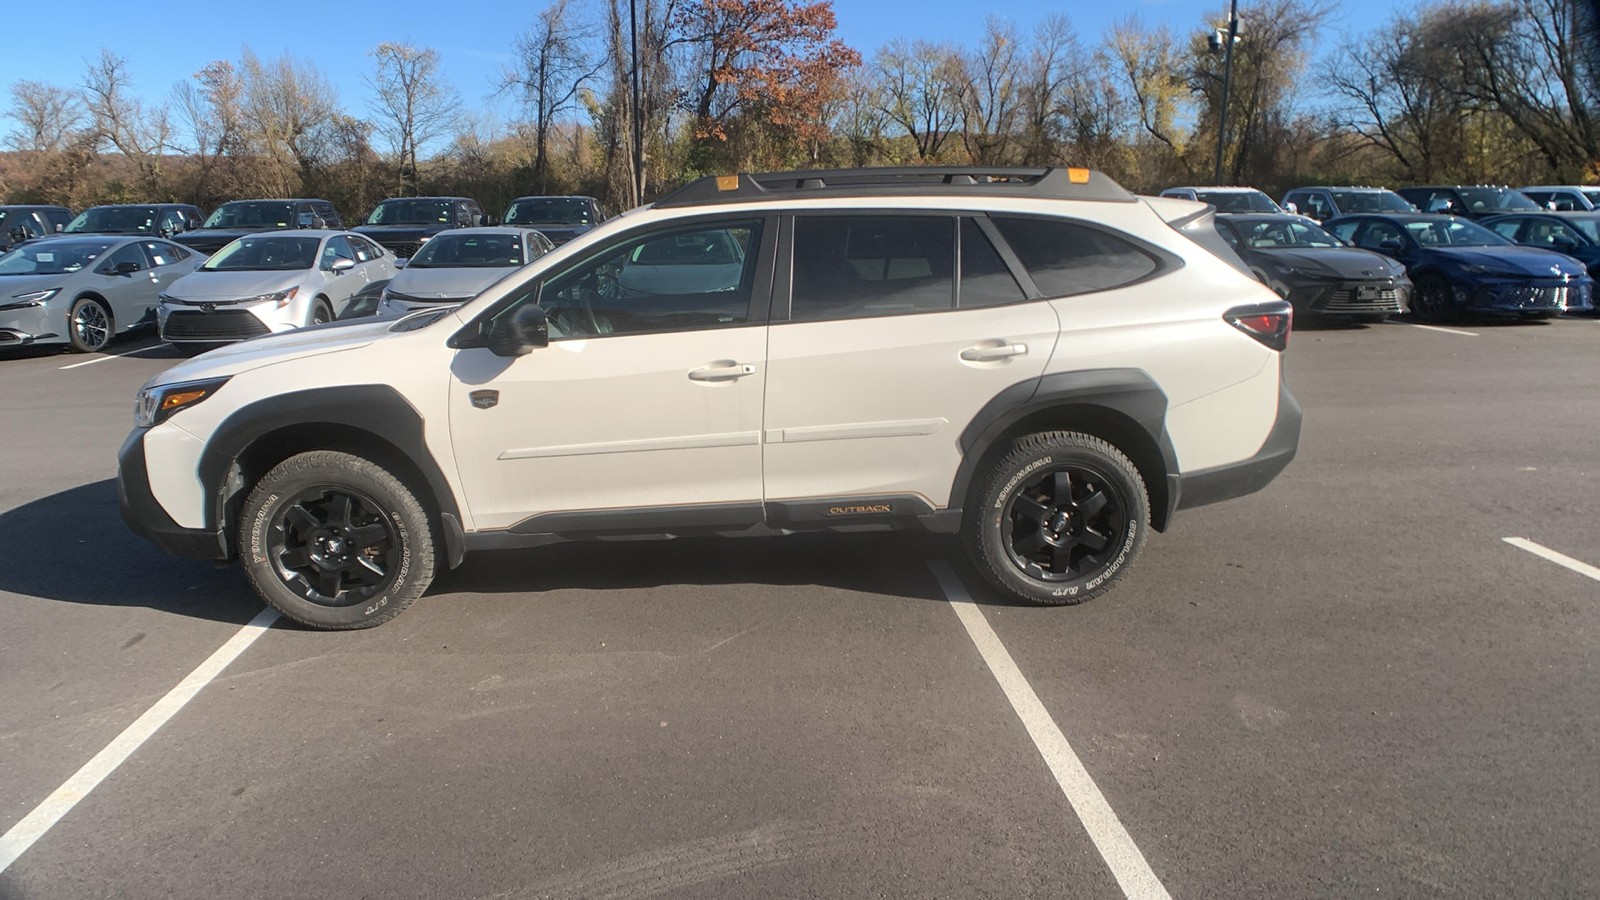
top-left (963, 431), bottom-right (1150, 605)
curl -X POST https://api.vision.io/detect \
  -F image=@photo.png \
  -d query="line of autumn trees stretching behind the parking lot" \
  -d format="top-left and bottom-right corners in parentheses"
top-left (0, 0), bottom-right (1600, 218)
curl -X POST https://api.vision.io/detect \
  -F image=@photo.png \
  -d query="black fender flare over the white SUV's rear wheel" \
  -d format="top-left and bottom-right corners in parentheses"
top-left (950, 368), bottom-right (1178, 532)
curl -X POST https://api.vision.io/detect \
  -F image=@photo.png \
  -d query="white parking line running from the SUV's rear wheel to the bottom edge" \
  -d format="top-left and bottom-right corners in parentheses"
top-left (928, 560), bottom-right (1171, 900)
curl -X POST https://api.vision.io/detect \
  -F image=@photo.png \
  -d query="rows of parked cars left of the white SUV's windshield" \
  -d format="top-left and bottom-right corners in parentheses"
top-left (0, 197), bottom-right (605, 352)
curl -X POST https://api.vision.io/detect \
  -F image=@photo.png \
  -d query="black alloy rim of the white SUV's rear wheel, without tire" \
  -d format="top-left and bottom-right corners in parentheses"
top-left (1002, 466), bottom-right (1128, 581)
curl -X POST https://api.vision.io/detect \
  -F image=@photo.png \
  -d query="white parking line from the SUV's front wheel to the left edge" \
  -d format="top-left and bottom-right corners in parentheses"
top-left (0, 607), bottom-right (278, 873)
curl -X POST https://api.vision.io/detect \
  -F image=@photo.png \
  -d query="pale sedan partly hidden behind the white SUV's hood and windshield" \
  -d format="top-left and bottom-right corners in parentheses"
top-left (378, 227), bottom-right (555, 317)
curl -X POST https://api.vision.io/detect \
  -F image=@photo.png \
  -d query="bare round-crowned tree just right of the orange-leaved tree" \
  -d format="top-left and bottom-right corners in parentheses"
top-left (872, 38), bottom-right (965, 162)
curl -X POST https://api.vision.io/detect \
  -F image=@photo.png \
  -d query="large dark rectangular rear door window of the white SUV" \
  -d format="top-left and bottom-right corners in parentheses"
top-left (789, 216), bottom-right (955, 322)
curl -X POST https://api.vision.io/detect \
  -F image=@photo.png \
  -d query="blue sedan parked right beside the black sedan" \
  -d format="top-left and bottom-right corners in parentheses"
top-left (1323, 213), bottom-right (1595, 320)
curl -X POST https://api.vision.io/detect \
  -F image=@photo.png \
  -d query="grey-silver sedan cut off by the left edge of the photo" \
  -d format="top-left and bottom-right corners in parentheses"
top-left (0, 235), bottom-right (206, 352)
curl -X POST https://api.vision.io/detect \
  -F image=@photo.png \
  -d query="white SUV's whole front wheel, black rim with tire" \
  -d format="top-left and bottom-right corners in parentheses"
top-left (238, 450), bottom-right (434, 629)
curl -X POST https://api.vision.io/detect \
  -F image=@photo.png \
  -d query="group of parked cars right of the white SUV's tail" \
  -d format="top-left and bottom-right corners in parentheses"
top-left (1162, 186), bottom-right (1600, 322)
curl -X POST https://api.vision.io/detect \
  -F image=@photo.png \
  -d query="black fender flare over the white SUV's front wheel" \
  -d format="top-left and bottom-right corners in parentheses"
top-left (198, 384), bottom-right (461, 562)
